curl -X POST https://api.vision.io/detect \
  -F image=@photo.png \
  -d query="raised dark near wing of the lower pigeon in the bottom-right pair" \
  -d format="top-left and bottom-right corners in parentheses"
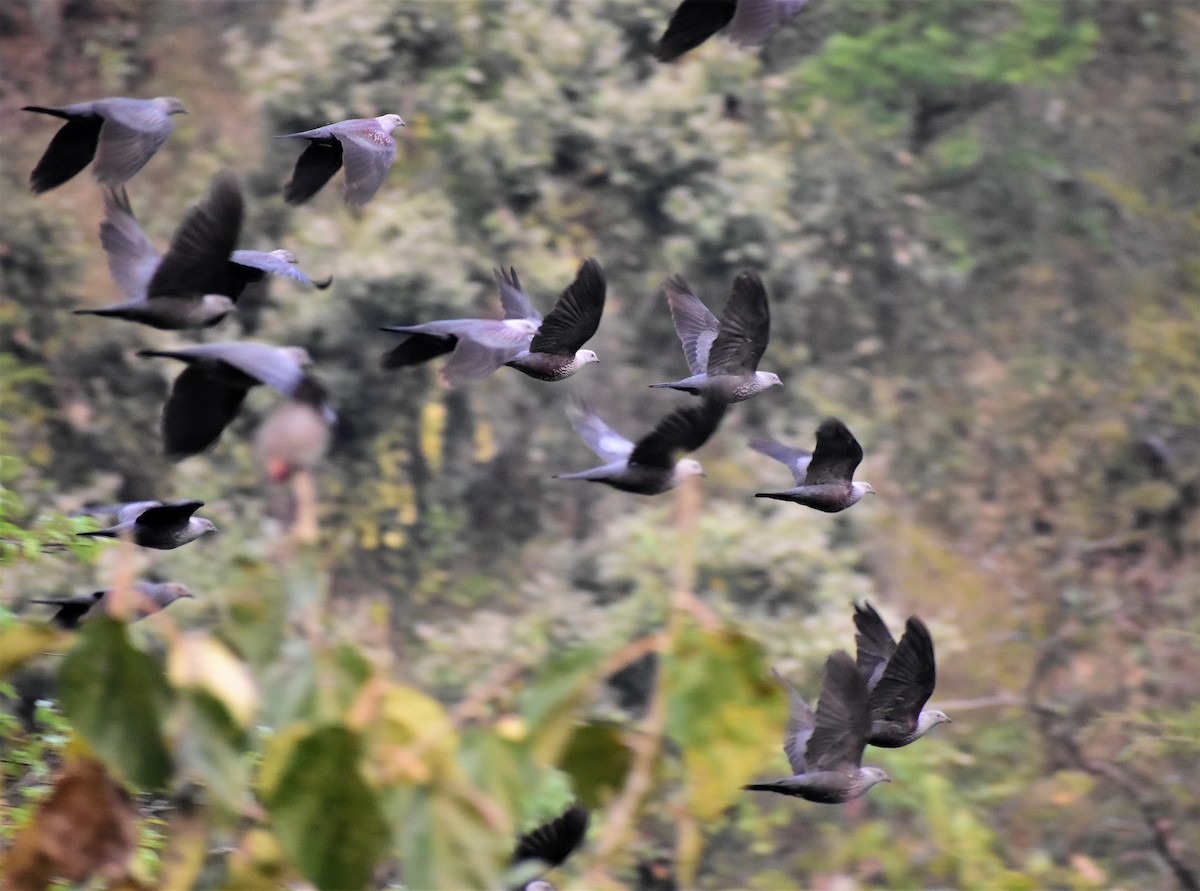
top-left (805, 650), bottom-right (871, 771)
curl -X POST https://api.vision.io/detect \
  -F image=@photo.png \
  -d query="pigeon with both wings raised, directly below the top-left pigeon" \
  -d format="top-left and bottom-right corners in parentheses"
top-left (76, 173), bottom-right (243, 330)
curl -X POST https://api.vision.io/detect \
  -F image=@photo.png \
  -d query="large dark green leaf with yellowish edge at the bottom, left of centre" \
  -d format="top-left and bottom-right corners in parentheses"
top-left (264, 726), bottom-right (388, 890)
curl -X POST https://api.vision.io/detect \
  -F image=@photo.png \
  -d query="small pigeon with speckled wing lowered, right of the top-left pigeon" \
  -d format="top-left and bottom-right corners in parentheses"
top-left (276, 114), bottom-right (404, 208)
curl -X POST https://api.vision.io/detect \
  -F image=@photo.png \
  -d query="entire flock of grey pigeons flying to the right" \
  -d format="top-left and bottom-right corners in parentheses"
top-left (16, 0), bottom-right (949, 887)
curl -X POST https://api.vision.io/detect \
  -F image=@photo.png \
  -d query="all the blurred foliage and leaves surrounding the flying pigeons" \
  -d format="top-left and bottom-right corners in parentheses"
top-left (0, 0), bottom-right (1200, 889)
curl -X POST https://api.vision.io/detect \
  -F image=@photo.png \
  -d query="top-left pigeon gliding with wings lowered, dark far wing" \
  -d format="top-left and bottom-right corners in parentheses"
top-left (23, 96), bottom-right (187, 193)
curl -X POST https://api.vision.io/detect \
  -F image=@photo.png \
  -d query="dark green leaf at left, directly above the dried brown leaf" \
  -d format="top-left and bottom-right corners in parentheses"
top-left (59, 617), bottom-right (172, 789)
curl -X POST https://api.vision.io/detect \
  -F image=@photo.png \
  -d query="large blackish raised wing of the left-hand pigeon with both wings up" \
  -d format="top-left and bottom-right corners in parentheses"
top-left (148, 173), bottom-right (244, 297)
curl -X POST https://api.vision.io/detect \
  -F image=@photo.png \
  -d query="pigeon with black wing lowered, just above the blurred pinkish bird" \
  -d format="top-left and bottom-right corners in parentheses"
top-left (138, 343), bottom-right (337, 458)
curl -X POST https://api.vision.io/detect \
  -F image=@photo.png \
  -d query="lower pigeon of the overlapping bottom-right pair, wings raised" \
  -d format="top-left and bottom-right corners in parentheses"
top-left (744, 650), bottom-right (890, 805)
